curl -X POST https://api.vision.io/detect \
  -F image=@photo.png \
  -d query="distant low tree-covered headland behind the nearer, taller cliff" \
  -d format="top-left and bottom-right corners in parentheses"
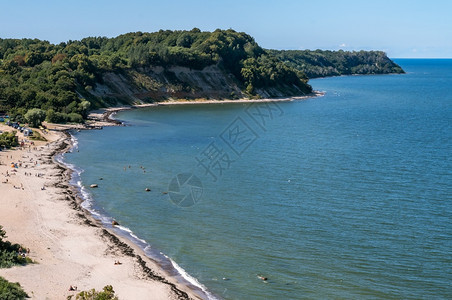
top-left (268, 50), bottom-right (404, 78)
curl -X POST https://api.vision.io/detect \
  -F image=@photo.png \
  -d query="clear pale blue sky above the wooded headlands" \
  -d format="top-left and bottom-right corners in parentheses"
top-left (0, 0), bottom-right (452, 58)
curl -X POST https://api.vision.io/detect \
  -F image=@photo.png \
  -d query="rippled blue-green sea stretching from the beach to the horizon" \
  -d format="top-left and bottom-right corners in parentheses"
top-left (65, 60), bottom-right (452, 299)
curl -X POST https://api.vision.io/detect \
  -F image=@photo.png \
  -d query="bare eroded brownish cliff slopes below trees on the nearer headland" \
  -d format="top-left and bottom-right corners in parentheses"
top-left (90, 65), bottom-right (304, 104)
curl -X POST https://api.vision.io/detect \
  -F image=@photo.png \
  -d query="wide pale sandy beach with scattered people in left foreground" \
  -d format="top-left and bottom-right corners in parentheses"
top-left (0, 124), bottom-right (199, 299)
